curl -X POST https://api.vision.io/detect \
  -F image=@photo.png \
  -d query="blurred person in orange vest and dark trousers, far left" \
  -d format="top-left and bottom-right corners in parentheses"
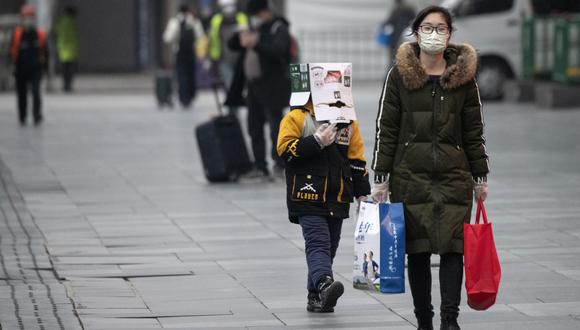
top-left (10, 4), bottom-right (48, 126)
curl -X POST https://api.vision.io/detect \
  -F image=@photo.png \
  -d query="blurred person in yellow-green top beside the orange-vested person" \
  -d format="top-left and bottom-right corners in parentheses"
top-left (55, 6), bottom-right (80, 92)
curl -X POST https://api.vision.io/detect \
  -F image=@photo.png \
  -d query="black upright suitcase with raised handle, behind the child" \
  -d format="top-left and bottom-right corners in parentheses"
top-left (195, 81), bottom-right (252, 182)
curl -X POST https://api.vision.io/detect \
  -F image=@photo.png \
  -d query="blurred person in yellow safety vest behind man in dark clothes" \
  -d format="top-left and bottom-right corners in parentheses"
top-left (208, 0), bottom-right (248, 93)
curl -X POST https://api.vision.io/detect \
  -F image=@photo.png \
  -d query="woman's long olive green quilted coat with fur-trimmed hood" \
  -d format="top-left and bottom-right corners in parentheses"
top-left (372, 43), bottom-right (489, 254)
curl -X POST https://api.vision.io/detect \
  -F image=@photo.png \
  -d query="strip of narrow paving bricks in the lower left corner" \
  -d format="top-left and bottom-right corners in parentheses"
top-left (0, 162), bottom-right (81, 330)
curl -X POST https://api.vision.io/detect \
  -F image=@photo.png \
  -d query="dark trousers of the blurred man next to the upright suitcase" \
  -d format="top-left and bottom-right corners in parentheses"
top-left (248, 85), bottom-right (284, 171)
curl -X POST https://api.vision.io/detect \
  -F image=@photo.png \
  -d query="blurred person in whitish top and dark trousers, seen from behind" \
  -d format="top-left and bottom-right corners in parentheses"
top-left (163, 5), bottom-right (205, 109)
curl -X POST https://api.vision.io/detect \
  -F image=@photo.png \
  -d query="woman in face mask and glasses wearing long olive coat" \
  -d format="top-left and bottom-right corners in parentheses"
top-left (371, 6), bottom-right (489, 330)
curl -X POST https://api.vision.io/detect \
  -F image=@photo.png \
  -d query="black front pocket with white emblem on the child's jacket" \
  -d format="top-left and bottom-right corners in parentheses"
top-left (292, 172), bottom-right (328, 203)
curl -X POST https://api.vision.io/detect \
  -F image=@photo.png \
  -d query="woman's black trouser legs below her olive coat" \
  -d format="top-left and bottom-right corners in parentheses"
top-left (407, 253), bottom-right (463, 319)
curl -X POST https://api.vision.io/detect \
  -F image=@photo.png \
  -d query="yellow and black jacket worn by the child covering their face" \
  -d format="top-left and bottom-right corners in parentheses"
top-left (277, 103), bottom-right (370, 223)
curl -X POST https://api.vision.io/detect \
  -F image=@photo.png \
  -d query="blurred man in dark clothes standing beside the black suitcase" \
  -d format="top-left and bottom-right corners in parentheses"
top-left (229, 0), bottom-right (290, 179)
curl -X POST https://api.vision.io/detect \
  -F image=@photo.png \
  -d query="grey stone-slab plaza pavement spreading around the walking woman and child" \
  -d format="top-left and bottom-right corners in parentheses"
top-left (0, 86), bottom-right (580, 330)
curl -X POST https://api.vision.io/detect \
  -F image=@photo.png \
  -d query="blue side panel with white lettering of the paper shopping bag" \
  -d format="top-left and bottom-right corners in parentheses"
top-left (379, 203), bottom-right (405, 293)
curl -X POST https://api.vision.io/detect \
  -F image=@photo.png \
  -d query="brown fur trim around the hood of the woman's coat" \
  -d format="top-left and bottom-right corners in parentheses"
top-left (396, 42), bottom-right (477, 90)
